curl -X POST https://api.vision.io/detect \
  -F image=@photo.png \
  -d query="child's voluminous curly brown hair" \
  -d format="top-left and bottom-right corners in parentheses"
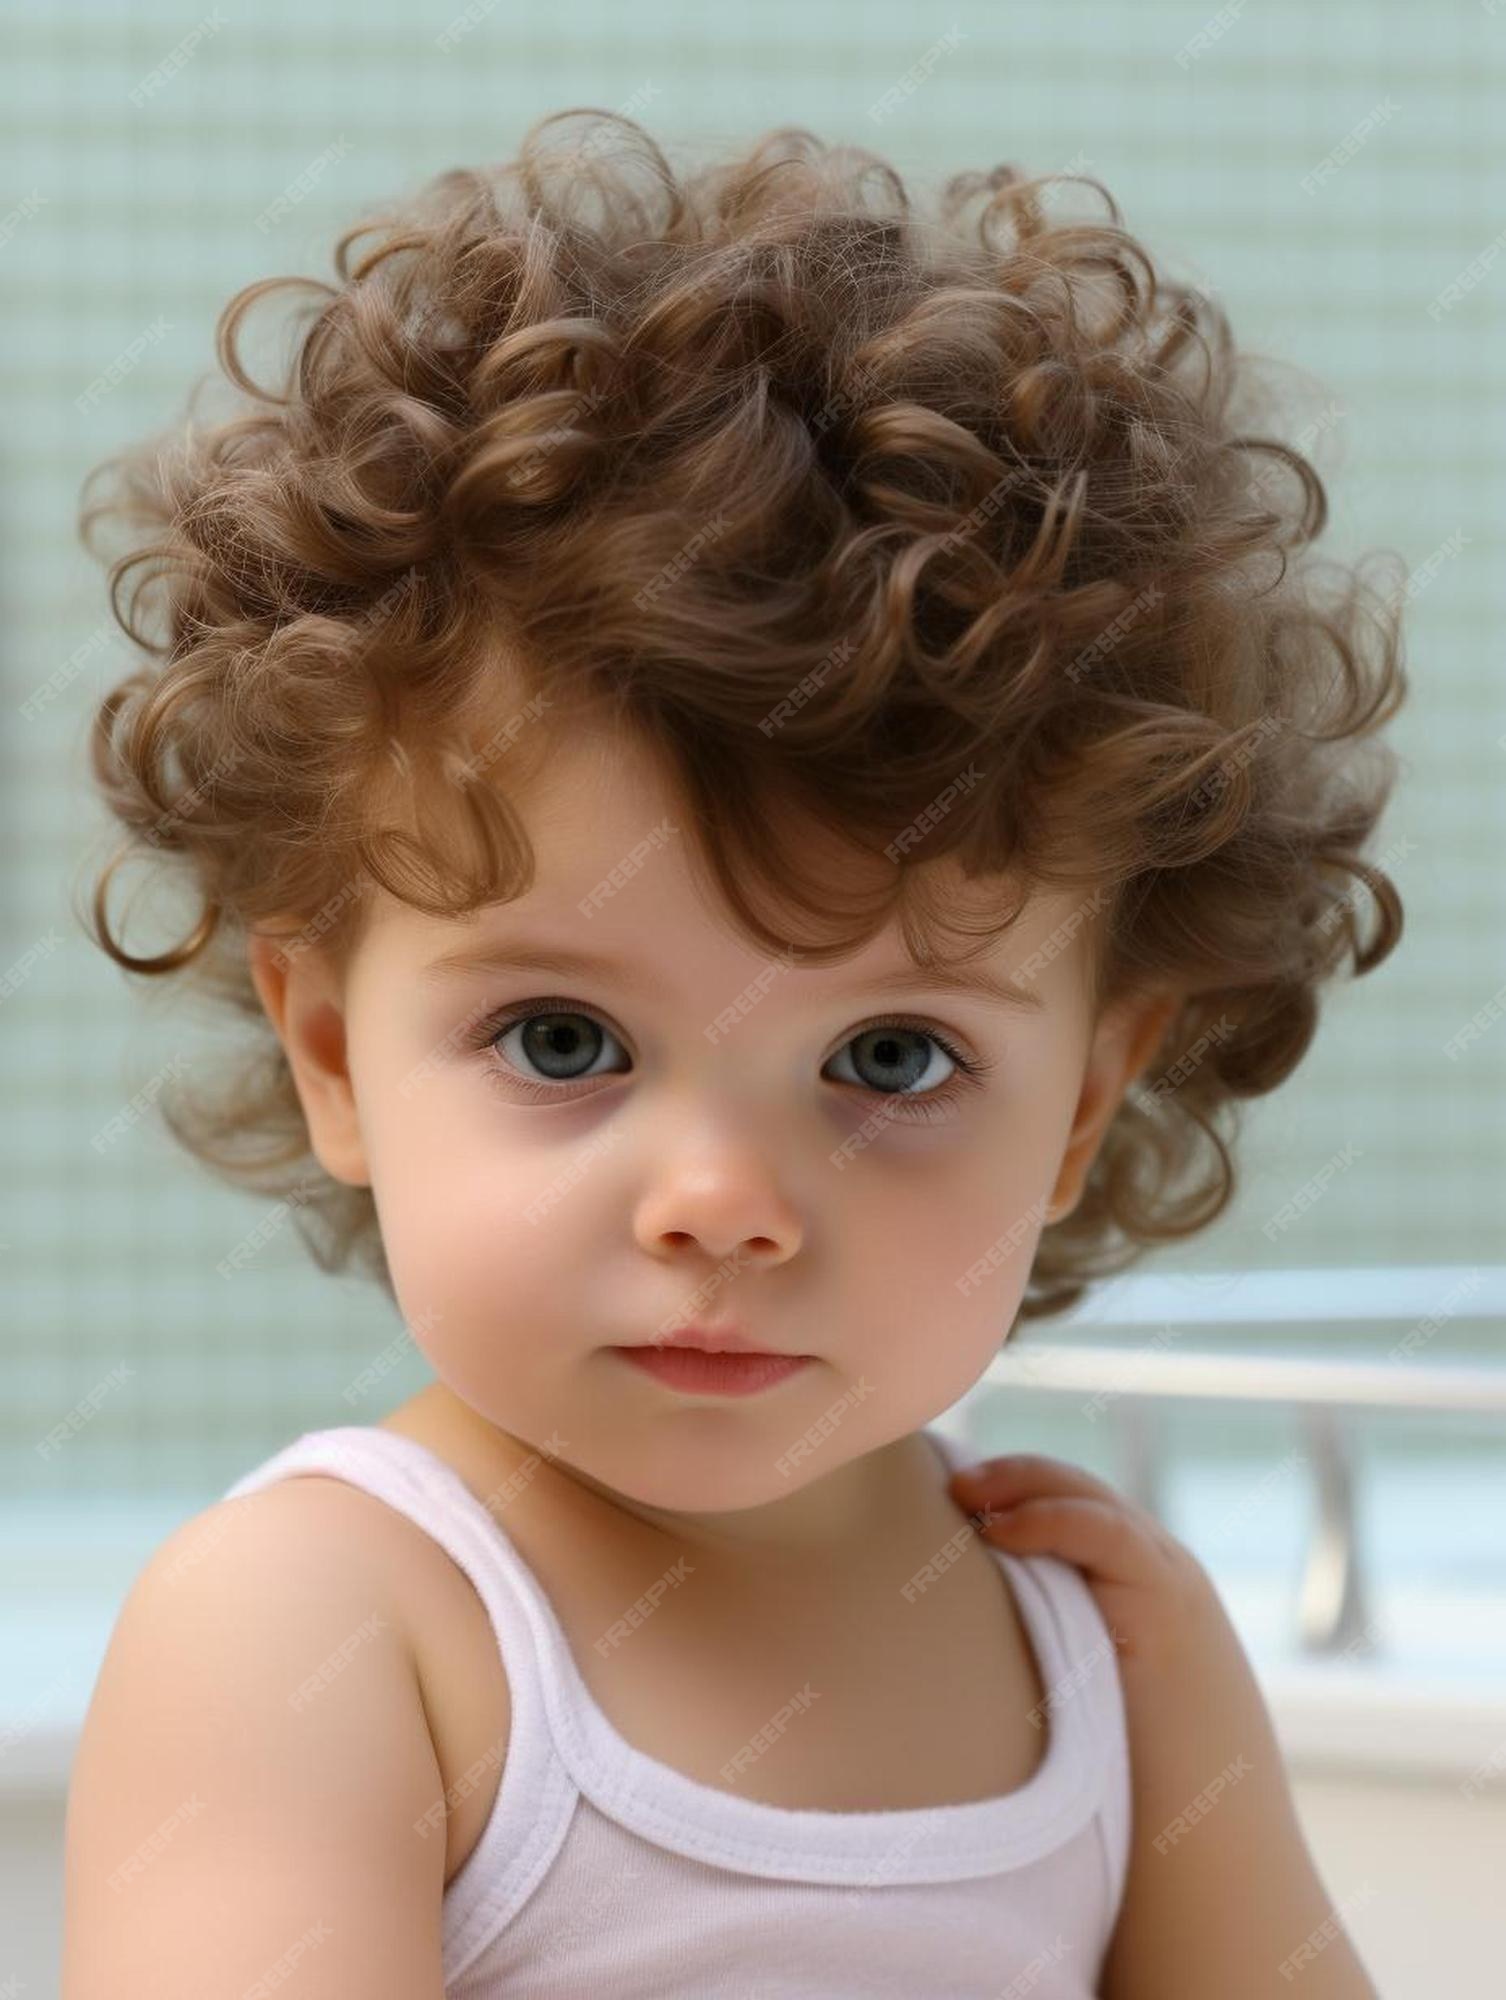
top-left (80, 108), bottom-right (1404, 1316)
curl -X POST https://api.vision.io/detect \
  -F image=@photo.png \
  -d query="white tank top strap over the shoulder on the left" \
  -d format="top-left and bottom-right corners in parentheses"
top-left (222, 1424), bottom-right (578, 1974)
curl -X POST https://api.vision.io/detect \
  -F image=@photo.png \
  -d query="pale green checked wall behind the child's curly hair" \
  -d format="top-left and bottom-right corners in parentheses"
top-left (0, 0), bottom-right (1506, 1498)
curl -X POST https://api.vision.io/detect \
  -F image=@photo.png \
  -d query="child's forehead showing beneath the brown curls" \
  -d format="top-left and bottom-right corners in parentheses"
top-left (368, 716), bottom-right (1094, 998)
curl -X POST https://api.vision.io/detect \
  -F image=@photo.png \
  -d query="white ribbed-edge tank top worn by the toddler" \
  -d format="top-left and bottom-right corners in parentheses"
top-left (224, 1424), bottom-right (1130, 2000)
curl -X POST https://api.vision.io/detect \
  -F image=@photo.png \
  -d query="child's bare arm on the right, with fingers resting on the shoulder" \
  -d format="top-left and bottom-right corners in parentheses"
top-left (952, 1456), bottom-right (1378, 2000)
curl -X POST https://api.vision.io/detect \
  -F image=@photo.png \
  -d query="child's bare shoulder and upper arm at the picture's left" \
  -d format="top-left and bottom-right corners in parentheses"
top-left (62, 1476), bottom-right (458, 2000)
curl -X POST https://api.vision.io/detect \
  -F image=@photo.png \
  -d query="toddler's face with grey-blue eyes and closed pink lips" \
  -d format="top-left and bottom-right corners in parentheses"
top-left (258, 734), bottom-right (1164, 1512)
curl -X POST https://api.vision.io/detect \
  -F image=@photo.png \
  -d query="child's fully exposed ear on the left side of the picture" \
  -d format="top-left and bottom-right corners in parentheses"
top-left (248, 932), bottom-right (372, 1188)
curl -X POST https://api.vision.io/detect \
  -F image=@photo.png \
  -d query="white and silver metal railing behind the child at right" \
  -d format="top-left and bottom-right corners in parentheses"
top-left (964, 1266), bottom-right (1506, 1656)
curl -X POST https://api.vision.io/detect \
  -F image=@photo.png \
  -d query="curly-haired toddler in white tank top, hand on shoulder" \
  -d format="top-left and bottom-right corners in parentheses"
top-left (64, 114), bottom-right (1404, 2000)
